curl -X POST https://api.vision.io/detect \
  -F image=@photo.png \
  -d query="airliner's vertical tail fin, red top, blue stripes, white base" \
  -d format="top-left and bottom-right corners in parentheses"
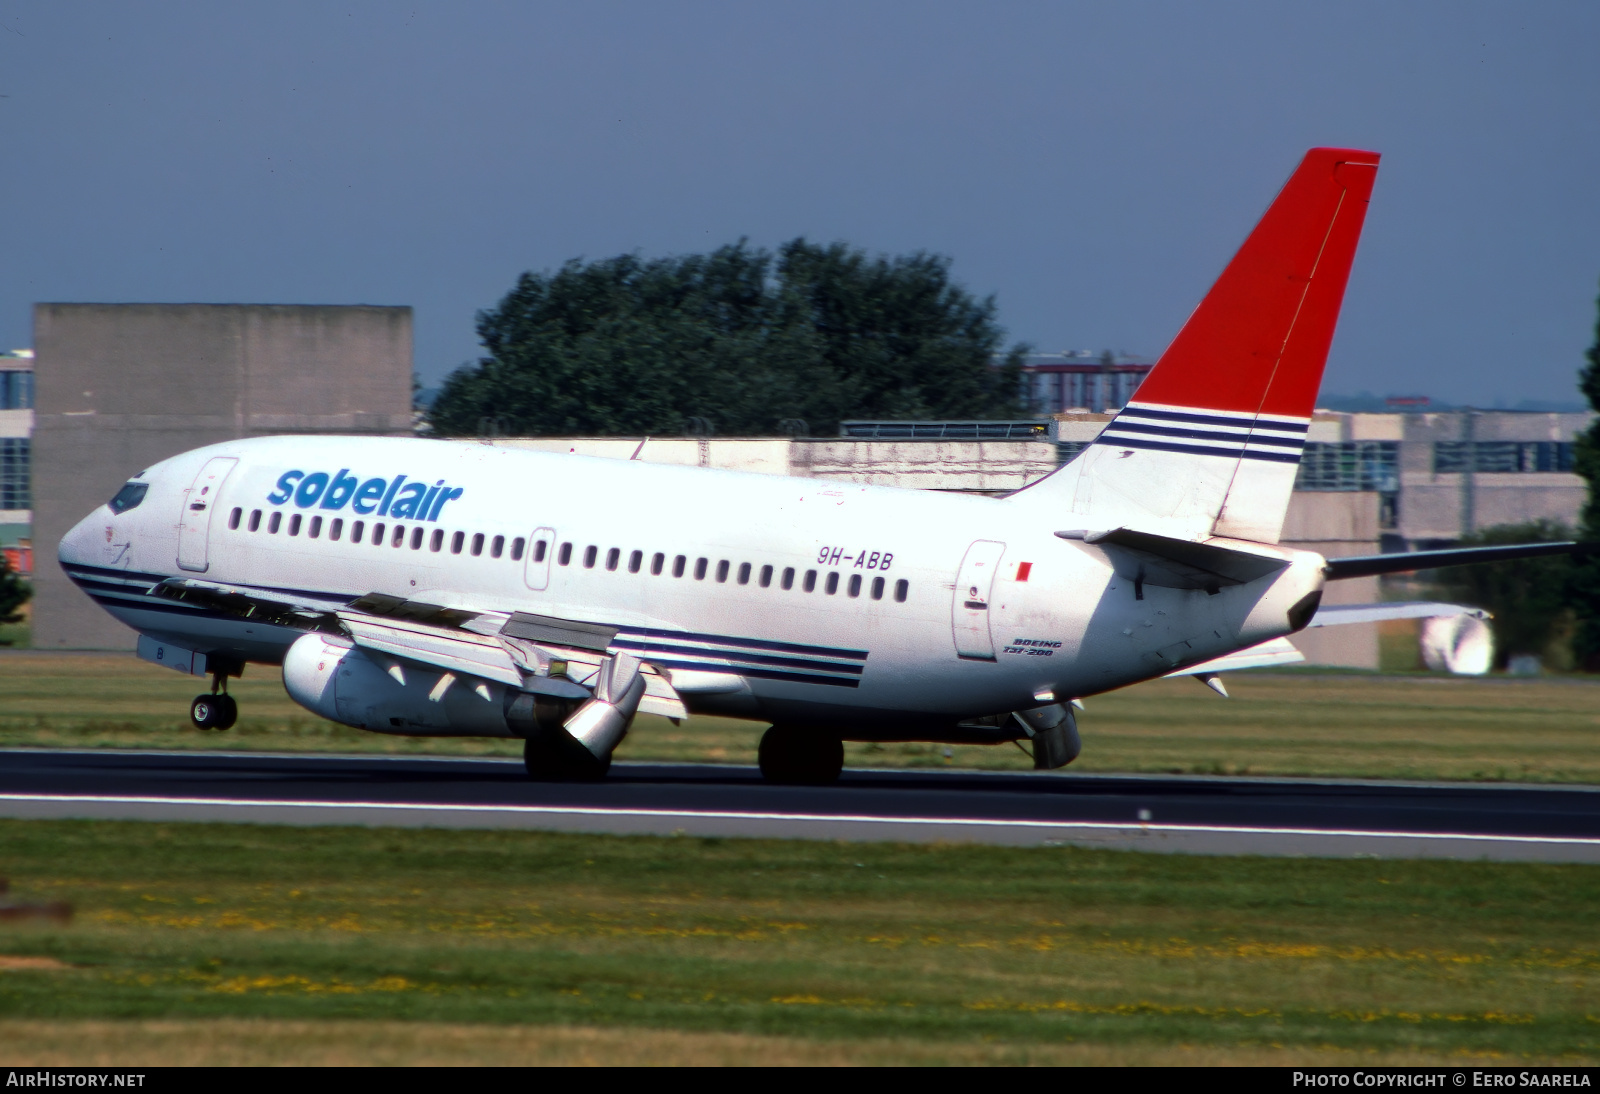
top-left (1024, 149), bottom-right (1378, 542)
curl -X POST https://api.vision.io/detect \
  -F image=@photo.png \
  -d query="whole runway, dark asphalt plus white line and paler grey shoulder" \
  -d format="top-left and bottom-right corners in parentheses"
top-left (0, 750), bottom-right (1600, 862)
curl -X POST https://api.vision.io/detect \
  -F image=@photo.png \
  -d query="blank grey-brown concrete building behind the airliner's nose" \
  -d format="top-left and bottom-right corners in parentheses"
top-left (32, 304), bottom-right (413, 649)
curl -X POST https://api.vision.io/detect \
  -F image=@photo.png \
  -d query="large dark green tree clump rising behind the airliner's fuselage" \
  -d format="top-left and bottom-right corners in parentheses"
top-left (429, 240), bottom-right (1026, 437)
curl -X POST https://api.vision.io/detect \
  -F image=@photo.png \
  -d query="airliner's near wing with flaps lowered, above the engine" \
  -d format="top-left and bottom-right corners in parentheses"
top-left (152, 577), bottom-right (704, 718)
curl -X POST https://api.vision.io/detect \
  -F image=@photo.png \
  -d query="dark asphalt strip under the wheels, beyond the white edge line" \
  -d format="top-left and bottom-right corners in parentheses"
top-left (0, 750), bottom-right (1600, 838)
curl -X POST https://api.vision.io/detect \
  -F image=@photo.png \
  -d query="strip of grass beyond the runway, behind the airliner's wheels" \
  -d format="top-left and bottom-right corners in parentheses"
top-left (0, 651), bottom-right (1600, 784)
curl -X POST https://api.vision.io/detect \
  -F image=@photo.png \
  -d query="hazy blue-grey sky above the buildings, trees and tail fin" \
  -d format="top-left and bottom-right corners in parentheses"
top-left (0, 0), bottom-right (1600, 405)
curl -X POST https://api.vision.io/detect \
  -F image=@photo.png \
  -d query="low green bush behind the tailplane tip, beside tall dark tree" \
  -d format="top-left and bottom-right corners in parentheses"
top-left (1438, 520), bottom-right (1573, 669)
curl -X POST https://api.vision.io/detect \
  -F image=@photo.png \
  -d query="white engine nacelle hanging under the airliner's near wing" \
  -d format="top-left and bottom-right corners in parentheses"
top-left (283, 633), bottom-right (578, 737)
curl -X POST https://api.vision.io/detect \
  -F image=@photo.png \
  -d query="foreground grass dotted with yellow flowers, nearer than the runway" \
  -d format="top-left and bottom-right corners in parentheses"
top-left (0, 821), bottom-right (1600, 1064)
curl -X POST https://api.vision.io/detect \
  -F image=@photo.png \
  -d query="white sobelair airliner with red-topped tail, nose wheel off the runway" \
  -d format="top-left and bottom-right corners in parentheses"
top-left (59, 149), bottom-right (1574, 782)
